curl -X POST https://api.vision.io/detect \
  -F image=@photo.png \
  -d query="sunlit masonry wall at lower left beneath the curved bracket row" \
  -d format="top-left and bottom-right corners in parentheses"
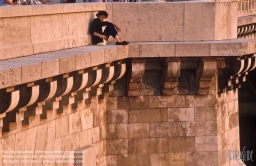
top-left (0, 97), bottom-right (106, 166)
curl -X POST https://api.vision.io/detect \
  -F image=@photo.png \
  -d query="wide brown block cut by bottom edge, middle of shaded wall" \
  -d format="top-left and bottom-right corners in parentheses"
top-left (150, 153), bottom-right (186, 166)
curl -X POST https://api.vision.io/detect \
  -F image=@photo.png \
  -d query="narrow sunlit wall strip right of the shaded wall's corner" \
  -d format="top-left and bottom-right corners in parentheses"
top-left (217, 90), bottom-right (242, 165)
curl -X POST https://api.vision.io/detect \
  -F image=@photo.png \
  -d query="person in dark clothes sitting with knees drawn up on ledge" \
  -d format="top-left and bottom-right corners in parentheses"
top-left (90, 10), bottom-right (129, 45)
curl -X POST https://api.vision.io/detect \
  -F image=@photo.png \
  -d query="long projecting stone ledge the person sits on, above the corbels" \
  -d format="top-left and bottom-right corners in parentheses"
top-left (0, 39), bottom-right (256, 89)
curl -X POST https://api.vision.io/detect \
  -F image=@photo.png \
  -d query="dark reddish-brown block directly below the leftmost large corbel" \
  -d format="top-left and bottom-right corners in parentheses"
top-left (129, 96), bottom-right (149, 109)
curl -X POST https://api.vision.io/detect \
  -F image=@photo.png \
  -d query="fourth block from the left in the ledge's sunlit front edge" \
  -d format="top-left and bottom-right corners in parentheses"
top-left (60, 56), bottom-right (76, 74)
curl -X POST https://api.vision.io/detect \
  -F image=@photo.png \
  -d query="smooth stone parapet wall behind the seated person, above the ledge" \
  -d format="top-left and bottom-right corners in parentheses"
top-left (0, 2), bottom-right (237, 59)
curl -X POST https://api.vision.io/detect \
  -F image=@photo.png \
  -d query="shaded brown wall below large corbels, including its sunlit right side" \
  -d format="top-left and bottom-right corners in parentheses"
top-left (106, 62), bottom-right (244, 166)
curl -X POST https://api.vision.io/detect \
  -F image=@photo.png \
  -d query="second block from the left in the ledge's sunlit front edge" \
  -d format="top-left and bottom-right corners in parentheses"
top-left (21, 63), bottom-right (42, 83)
